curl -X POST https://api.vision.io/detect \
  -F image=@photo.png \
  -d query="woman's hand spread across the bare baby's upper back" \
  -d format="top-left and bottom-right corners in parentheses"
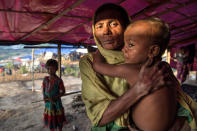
top-left (135, 59), bottom-right (180, 95)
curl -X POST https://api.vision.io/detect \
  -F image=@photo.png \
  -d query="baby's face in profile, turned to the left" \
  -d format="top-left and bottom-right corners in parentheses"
top-left (122, 22), bottom-right (152, 64)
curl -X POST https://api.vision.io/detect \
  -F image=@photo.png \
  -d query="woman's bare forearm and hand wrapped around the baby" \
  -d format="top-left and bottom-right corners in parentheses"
top-left (99, 58), bottom-right (164, 126)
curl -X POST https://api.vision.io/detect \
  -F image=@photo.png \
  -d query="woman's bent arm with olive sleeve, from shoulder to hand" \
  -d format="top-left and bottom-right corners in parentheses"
top-left (80, 53), bottom-right (169, 126)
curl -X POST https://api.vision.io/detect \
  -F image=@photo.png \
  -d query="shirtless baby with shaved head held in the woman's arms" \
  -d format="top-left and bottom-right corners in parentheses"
top-left (93, 18), bottom-right (176, 131)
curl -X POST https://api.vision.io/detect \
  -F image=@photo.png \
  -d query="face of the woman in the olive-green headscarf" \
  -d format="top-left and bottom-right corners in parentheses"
top-left (95, 10), bottom-right (125, 50)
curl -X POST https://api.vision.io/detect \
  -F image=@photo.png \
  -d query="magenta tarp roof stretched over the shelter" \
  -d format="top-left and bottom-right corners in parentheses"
top-left (0, 0), bottom-right (197, 46)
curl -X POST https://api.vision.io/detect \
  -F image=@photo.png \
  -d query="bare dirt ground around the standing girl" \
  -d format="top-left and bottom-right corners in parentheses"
top-left (0, 76), bottom-right (91, 131)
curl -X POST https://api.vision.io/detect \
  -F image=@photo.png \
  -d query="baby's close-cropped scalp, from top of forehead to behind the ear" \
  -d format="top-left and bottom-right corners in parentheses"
top-left (126, 17), bottom-right (170, 57)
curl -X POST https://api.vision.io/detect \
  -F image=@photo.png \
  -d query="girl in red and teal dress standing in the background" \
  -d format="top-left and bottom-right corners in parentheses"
top-left (42, 59), bottom-right (66, 131)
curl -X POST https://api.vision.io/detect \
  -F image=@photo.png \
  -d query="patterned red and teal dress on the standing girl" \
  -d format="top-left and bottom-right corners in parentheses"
top-left (42, 77), bottom-right (66, 131)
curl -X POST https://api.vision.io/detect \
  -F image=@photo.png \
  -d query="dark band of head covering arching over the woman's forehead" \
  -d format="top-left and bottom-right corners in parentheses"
top-left (94, 3), bottom-right (130, 28)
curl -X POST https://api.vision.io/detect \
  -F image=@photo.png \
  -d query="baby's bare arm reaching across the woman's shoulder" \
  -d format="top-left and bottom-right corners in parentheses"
top-left (93, 50), bottom-right (139, 78)
